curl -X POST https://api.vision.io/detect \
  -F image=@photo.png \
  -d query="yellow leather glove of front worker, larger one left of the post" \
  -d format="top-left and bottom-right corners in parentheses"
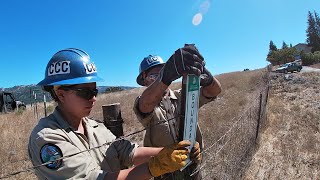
top-left (149, 141), bottom-right (191, 177)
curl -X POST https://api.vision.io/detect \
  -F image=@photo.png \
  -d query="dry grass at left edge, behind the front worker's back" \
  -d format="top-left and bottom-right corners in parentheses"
top-left (0, 104), bottom-right (53, 179)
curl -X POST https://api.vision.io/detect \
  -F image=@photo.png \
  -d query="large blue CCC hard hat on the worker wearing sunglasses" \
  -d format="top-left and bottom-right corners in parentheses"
top-left (38, 48), bottom-right (103, 86)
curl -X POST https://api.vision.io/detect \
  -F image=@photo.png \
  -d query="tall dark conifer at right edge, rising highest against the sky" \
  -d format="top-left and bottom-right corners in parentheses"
top-left (306, 11), bottom-right (320, 52)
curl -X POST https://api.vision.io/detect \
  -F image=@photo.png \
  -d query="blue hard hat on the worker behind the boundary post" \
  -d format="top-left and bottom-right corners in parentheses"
top-left (137, 55), bottom-right (165, 86)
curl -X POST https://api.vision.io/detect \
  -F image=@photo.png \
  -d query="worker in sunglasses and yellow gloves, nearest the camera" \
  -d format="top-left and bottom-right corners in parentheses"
top-left (28, 48), bottom-right (200, 179)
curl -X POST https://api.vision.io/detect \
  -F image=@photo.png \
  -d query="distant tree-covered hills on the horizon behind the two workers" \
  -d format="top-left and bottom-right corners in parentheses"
top-left (0, 84), bottom-right (135, 104)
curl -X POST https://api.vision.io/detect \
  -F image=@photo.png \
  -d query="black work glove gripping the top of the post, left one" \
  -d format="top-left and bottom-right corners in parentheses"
top-left (161, 44), bottom-right (205, 86)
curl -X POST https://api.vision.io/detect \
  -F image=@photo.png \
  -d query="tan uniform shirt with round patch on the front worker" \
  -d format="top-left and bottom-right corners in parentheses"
top-left (28, 109), bottom-right (137, 179)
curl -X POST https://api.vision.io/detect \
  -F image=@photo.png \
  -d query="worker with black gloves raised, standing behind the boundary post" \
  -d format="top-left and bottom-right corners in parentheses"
top-left (133, 45), bottom-right (221, 180)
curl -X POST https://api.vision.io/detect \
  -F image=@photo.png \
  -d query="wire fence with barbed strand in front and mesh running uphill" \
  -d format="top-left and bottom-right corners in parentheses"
top-left (0, 67), bottom-right (269, 179)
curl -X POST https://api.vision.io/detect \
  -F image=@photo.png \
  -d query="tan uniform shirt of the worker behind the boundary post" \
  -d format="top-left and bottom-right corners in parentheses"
top-left (133, 90), bottom-right (214, 148)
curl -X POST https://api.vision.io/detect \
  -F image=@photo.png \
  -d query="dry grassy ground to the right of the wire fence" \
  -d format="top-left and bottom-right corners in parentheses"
top-left (244, 73), bottom-right (320, 179)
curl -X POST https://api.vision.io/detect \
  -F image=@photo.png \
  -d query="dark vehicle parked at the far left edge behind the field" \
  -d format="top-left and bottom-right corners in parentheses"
top-left (0, 91), bottom-right (26, 112)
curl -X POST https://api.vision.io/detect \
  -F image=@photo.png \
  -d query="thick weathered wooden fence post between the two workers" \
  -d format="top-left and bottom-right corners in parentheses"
top-left (102, 103), bottom-right (123, 138)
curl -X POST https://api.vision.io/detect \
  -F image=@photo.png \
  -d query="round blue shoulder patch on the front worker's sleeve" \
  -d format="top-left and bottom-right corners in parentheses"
top-left (40, 143), bottom-right (62, 169)
